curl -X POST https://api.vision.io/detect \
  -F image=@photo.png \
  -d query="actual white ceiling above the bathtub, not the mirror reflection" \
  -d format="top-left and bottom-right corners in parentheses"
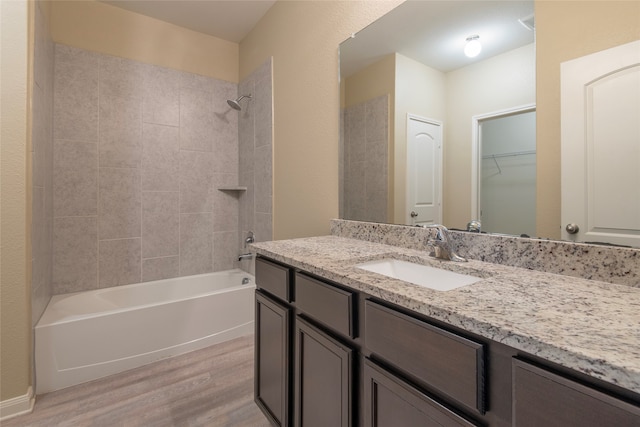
top-left (101, 0), bottom-right (275, 43)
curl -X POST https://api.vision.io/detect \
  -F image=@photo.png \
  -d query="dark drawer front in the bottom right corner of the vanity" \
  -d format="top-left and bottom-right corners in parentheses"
top-left (513, 359), bottom-right (640, 427)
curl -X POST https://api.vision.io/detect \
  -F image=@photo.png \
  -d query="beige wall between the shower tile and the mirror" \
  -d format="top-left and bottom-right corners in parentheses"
top-left (240, 1), bottom-right (401, 239)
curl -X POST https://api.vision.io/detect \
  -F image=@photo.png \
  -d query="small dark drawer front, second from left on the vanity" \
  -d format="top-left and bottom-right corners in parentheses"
top-left (296, 273), bottom-right (355, 338)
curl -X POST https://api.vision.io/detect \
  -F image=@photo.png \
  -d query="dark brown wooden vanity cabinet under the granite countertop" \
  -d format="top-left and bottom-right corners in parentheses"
top-left (255, 257), bottom-right (640, 427)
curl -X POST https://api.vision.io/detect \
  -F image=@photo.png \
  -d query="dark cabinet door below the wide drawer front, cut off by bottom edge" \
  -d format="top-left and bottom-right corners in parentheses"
top-left (363, 360), bottom-right (474, 427)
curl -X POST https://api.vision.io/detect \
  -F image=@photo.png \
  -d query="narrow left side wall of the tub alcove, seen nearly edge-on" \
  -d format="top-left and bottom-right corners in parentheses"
top-left (31, 1), bottom-right (54, 324)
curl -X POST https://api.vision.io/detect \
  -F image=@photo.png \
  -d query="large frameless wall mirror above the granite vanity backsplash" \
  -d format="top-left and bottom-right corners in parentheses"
top-left (339, 0), bottom-right (640, 247)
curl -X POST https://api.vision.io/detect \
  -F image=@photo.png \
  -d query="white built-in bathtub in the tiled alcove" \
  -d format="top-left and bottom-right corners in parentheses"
top-left (35, 269), bottom-right (255, 394)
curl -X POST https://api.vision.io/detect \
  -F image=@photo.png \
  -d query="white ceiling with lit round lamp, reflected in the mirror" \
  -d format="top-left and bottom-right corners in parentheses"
top-left (340, 0), bottom-right (534, 77)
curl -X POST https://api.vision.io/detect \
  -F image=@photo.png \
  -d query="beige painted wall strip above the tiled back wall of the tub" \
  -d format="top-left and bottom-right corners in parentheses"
top-left (51, 0), bottom-right (239, 83)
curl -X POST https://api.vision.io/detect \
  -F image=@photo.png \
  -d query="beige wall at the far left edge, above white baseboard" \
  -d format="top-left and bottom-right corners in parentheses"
top-left (0, 1), bottom-right (33, 404)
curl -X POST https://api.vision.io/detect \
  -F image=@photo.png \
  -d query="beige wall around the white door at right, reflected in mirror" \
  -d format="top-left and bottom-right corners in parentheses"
top-left (535, 0), bottom-right (640, 238)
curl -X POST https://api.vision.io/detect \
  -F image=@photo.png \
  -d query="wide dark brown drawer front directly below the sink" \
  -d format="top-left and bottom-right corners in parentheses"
top-left (364, 301), bottom-right (485, 414)
